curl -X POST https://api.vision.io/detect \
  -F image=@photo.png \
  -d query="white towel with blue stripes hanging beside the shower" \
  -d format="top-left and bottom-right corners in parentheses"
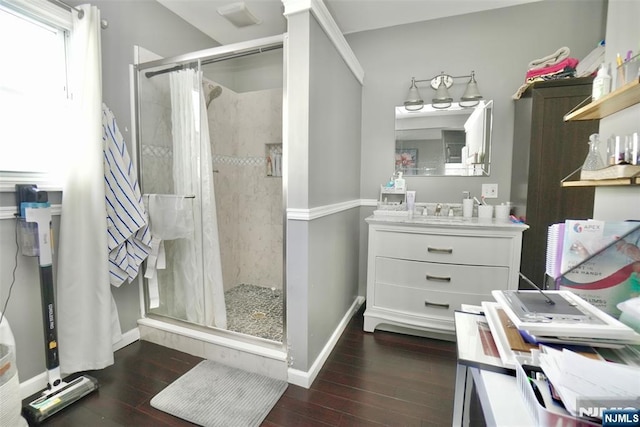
top-left (102, 104), bottom-right (151, 286)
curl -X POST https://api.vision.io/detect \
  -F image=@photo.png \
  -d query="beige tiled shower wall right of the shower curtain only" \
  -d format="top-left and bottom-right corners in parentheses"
top-left (208, 88), bottom-right (283, 290)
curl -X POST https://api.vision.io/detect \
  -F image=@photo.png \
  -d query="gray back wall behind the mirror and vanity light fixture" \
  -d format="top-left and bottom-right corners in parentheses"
top-left (347, 0), bottom-right (606, 295)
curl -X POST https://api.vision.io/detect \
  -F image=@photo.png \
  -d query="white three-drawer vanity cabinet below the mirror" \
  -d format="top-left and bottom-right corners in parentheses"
top-left (364, 216), bottom-right (528, 338)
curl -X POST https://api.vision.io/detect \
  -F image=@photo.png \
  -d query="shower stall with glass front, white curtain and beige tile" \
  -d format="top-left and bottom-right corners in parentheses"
top-left (133, 36), bottom-right (286, 360)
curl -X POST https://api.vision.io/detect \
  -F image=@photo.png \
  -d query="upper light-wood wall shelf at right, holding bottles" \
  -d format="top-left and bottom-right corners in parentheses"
top-left (564, 77), bottom-right (640, 122)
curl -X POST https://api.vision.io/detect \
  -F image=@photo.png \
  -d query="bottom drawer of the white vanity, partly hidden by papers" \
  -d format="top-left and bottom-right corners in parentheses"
top-left (373, 283), bottom-right (492, 319)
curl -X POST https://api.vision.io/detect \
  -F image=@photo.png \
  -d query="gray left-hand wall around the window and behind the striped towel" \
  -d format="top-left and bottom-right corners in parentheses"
top-left (0, 0), bottom-right (219, 381)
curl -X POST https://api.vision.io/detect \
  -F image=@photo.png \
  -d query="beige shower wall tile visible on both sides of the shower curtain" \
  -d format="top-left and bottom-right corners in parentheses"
top-left (140, 62), bottom-right (283, 311)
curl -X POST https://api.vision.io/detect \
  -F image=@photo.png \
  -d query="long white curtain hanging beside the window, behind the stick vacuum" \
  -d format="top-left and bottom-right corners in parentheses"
top-left (56, 5), bottom-right (114, 373)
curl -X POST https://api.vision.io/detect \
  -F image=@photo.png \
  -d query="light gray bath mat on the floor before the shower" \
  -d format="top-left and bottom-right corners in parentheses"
top-left (151, 360), bottom-right (287, 427)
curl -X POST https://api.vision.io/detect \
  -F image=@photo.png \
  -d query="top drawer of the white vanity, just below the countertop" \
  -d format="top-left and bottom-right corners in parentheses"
top-left (374, 230), bottom-right (513, 266)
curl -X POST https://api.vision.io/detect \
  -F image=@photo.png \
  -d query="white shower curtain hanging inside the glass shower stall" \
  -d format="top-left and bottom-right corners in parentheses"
top-left (170, 69), bottom-right (227, 329)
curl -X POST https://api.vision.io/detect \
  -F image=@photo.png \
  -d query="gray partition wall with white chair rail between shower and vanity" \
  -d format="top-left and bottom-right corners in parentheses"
top-left (285, 12), bottom-right (362, 371)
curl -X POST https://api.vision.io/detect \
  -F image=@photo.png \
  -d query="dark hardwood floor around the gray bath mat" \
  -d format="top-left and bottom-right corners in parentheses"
top-left (25, 309), bottom-right (468, 427)
